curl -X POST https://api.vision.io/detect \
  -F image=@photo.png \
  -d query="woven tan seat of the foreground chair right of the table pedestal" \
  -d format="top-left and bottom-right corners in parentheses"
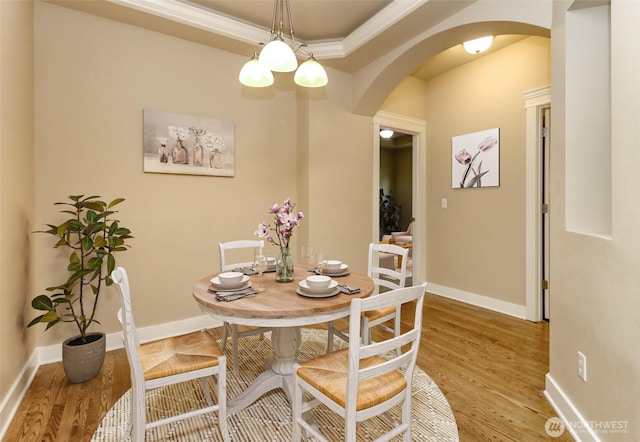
top-left (297, 348), bottom-right (407, 411)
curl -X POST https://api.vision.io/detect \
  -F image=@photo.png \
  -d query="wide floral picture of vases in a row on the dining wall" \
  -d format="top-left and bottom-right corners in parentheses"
top-left (143, 109), bottom-right (235, 177)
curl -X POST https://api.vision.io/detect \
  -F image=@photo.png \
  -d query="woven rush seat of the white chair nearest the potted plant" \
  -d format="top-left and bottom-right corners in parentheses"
top-left (138, 331), bottom-right (222, 381)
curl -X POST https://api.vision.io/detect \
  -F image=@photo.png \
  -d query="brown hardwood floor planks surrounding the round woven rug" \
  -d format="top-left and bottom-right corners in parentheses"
top-left (4, 295), bottom-right (572, 442)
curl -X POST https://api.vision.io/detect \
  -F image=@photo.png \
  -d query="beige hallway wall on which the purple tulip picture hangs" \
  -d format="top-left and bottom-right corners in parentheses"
top-left (383, 37), bottom-right (550, 306)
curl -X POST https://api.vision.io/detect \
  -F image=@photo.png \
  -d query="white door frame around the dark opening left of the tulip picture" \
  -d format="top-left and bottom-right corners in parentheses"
top-left (371, 111), bottom-right (428, 285)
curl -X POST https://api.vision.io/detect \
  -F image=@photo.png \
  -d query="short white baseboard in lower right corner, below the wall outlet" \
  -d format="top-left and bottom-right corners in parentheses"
top-left (544, 373), bottom-right (600, 442)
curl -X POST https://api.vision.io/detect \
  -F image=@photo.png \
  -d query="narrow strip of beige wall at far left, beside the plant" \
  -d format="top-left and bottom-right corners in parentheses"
top-left (0, 1), bottom-right (34, 406)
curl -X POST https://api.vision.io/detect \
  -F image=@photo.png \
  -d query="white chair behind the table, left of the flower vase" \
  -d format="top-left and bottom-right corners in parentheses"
top-left (218, 239), bottom-right (271, 375)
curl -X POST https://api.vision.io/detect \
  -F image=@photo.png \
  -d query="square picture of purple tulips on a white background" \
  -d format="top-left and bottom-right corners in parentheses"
top-left (451, 128), bottom-right (500, 189)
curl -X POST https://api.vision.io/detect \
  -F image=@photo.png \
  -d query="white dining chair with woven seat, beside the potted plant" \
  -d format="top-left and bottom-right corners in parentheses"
top-left (111, 267), bottom-right (229, 442)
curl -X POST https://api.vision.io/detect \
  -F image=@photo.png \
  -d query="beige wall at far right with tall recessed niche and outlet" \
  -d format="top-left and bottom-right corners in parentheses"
top-left (550, 1), bottom-right (640, 441)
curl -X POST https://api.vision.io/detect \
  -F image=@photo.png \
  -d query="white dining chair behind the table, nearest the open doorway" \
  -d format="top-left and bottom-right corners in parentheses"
top-left (327, 243), bottom-right (409, 352)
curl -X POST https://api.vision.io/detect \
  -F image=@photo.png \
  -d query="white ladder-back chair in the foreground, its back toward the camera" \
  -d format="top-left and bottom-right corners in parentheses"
top-left (292, 283), bottom-right (427, 442)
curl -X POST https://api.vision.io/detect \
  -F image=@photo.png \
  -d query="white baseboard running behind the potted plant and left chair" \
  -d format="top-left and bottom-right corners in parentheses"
top-left (0, 315), bottom-right (222, 440)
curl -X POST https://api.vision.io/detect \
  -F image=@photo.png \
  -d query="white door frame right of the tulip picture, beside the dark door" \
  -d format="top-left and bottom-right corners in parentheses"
top-left (524, 86), bottom-right (551, 322)
